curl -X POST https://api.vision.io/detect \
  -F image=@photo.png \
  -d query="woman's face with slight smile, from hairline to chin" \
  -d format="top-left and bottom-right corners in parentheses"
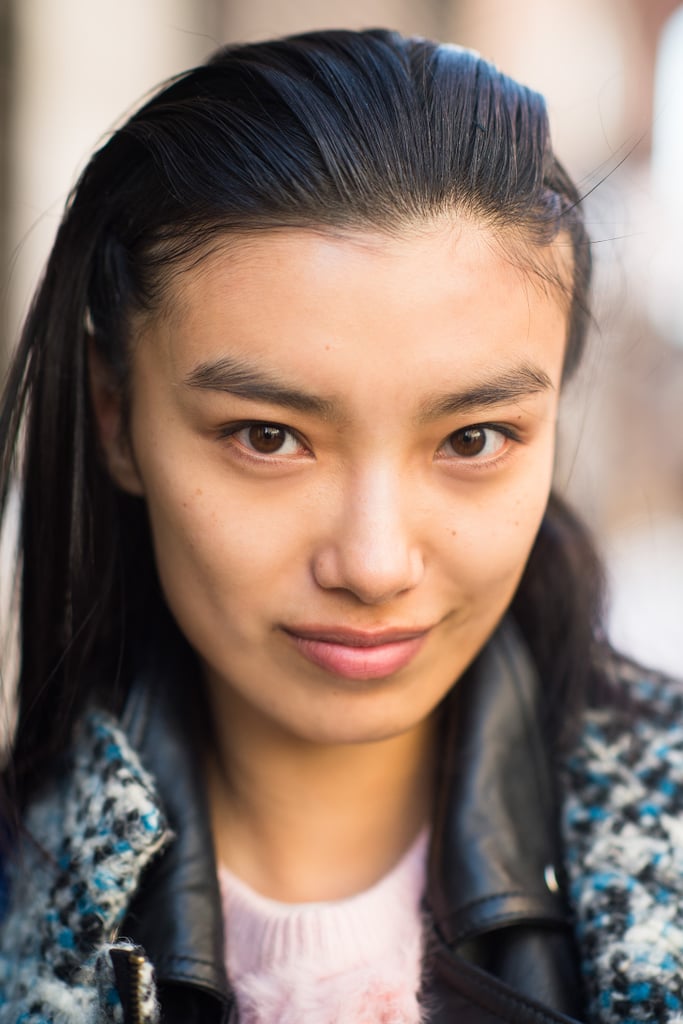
top-left (100, 220), bottom-right (566, 743)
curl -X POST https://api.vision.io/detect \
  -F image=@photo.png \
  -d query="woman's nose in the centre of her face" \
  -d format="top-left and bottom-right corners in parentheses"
top-left (313, 467), bottom-right (424, 604)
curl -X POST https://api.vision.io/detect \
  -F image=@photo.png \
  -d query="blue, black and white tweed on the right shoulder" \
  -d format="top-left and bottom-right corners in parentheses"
top-left (563, 675), bottom-right (683, 1024)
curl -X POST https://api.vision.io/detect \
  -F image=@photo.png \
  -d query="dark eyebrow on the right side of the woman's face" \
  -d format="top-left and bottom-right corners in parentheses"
top-left (419, 362), bottom-right (554, 423)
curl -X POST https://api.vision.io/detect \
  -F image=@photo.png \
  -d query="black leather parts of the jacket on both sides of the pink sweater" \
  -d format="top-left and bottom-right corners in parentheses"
top-left (121, 626), bottom-right (584, 1024)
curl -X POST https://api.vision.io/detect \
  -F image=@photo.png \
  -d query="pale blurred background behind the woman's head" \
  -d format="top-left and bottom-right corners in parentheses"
top-left (0, 0), bottom-right (683, 675)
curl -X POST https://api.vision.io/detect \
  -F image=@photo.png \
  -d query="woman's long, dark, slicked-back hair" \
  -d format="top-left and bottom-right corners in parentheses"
top-left (0, 25), bottom-right (596, 800)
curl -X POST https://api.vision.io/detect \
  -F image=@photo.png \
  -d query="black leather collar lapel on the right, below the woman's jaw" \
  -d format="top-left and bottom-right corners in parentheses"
top-left (427, 621), bottom-right (566, 947)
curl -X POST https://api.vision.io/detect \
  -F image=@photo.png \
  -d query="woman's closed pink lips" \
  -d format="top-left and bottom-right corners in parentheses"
top-left (285, 627), bottom-right (431, 680)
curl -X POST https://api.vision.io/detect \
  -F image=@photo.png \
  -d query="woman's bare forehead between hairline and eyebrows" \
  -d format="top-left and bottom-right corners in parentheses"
top-left (137, 218), bottom-right (570, 388)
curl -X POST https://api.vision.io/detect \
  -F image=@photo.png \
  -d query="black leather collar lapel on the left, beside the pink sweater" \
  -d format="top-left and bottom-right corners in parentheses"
top-left (121, 658), bottom-right (230, 1007)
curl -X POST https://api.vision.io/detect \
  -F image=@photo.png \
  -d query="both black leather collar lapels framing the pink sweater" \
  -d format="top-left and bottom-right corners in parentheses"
top-left (122, 623), bottom-right (566, 1000)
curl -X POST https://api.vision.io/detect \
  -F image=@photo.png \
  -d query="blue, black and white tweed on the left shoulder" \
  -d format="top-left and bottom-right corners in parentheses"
top-left (0, 713), bottom-right (170, 1024)
